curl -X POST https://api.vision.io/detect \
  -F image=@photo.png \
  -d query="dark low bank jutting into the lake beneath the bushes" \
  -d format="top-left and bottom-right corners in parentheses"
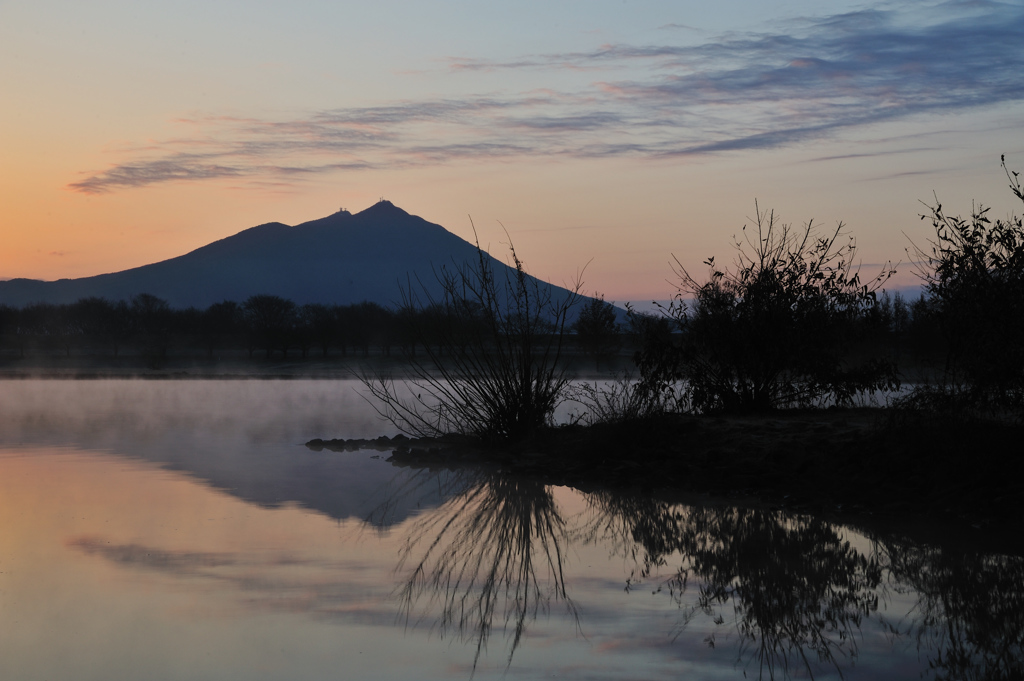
top-left (307, 409), bottom-right (1024, 548)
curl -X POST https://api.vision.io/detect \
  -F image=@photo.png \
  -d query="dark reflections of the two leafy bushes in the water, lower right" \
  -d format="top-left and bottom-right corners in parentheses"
top-left (584, 493), bottom-right (1024, 679)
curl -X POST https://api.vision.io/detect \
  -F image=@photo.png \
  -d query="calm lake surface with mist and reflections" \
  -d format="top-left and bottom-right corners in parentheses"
top-left (0, 380), bottom-right (1024, 681)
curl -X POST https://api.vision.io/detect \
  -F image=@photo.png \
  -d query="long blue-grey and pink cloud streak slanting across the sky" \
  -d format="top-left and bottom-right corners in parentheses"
top-left (69, 2), bottom-right (1024, 194)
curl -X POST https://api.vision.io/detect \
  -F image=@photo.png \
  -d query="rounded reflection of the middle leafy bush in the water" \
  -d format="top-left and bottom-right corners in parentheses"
top-left (674, 509), bottom-right (882, 675)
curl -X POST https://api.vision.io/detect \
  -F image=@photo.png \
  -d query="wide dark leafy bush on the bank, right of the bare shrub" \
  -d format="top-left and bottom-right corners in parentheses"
top-left (637, 204), bottom-right (898, 413)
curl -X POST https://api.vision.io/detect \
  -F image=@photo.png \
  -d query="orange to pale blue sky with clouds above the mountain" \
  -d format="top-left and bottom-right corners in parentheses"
top-left (0, 0), bottom-right (1024, 301)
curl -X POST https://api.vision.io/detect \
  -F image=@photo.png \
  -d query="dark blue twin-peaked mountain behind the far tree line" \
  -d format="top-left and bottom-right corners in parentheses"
top-left (0, 201), bottom-right (577, 308)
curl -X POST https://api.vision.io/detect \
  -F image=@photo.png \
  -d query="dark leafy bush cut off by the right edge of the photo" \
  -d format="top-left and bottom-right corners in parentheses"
top-left (916, 158), bottom-right (1024, 409)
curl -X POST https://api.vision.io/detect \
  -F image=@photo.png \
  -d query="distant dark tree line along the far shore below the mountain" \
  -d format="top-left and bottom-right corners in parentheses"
top-left (0, 284), bottom-right (937, 367)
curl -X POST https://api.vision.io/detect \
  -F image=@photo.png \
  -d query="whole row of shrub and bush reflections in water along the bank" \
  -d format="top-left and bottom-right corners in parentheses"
top-left (391, 474), bottom-right (1024, 679)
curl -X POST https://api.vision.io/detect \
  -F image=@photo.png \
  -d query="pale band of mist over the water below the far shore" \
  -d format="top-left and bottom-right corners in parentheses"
top-left (0, 379), bottom-right (397, 444)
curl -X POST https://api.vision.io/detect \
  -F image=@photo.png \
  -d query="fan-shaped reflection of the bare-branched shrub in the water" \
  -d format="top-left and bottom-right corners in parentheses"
top-left (398, 475), bottom-right (575, 670)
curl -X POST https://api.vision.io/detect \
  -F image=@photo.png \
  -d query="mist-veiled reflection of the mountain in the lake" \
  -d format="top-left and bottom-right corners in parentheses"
top-left (0, 381), bottom-right (456, 523)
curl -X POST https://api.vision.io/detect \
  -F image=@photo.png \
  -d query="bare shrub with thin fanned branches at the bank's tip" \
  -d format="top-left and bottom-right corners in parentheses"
top-left (364, 228), bottom-right (583, 440)
